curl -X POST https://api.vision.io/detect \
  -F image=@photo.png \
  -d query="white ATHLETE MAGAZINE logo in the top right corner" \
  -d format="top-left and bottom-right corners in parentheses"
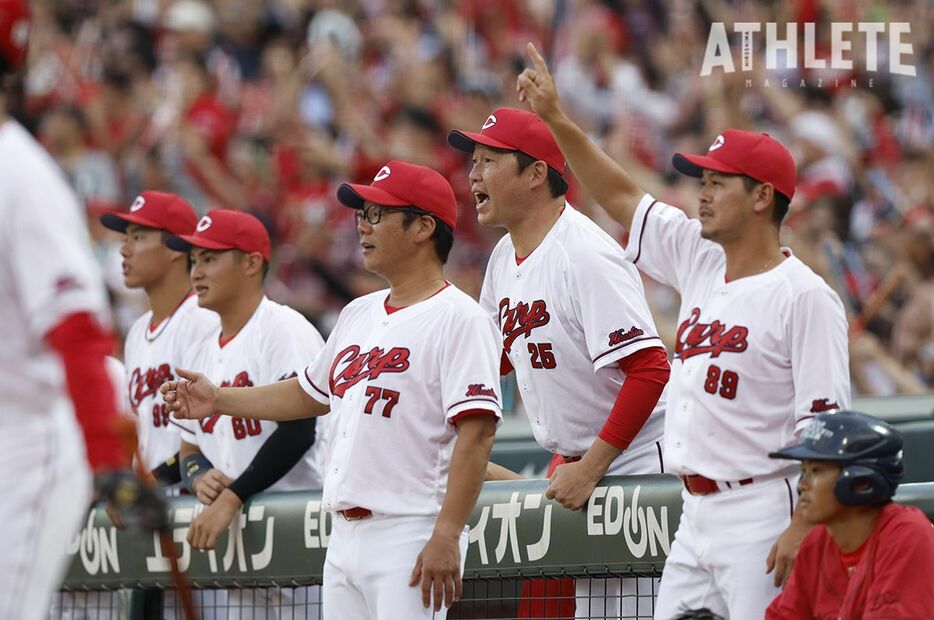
top-left (700, 22), bottom-right (917, 88)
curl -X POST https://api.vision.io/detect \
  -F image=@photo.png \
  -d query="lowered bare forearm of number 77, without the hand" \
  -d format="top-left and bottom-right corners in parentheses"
top-left (435, 414), bottom-right (496, 537)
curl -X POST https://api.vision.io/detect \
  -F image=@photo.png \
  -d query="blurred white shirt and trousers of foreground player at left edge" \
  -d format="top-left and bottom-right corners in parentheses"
top-left (0, 120), bottom-right (107, 620)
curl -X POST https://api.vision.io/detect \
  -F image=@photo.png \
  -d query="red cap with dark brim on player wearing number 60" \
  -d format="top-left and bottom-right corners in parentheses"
top-left (165, 209), bottom-right (270, 261)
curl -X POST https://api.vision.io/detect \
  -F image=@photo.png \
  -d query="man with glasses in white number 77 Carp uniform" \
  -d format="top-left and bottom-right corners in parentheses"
top-left (162, 161), bottom-right (501, 620)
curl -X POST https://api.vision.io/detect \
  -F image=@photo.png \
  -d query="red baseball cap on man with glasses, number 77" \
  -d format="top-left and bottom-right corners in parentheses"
top-left (337, 161), bottom-right (457, 230)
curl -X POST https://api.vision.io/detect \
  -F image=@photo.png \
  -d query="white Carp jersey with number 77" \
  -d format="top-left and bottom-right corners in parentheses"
top-left (299, 285), bottom-right (502, 516)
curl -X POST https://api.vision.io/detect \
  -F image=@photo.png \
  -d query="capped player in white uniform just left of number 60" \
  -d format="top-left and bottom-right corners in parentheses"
top-left (100, 191), bottom-right (218, 485)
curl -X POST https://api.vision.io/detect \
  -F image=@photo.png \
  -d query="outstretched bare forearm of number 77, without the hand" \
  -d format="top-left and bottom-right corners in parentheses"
top-left (215, 378), bottom-right (329, 421)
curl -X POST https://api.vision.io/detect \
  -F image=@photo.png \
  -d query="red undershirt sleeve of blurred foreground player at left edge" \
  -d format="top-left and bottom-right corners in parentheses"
top-left (46, 312), bottom-right (129, 470)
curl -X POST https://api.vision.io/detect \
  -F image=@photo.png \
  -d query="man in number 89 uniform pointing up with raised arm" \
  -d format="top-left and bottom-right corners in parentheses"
top-left (518, 44), bottom-right (850, 619)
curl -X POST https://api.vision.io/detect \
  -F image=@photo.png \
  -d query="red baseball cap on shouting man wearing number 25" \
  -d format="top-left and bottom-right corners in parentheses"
top-left (448, 108), bottom-right (567, 175)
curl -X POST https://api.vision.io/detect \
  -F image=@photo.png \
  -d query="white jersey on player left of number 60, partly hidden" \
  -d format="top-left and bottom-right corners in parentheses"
top-left (123, 295), bottom-right (220, 470)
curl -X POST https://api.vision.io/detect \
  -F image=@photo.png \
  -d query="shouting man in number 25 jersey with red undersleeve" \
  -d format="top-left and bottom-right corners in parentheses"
top-left (448, 108), bottom-right (670, 618)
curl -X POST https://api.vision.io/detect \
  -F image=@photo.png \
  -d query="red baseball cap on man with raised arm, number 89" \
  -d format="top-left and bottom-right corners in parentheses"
top-left (671, 129), bottom-right (797, 200)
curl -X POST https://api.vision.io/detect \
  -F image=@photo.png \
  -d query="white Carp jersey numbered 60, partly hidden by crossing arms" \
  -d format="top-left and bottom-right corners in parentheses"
top-left (182, 297), bottom-right (327, 491)
